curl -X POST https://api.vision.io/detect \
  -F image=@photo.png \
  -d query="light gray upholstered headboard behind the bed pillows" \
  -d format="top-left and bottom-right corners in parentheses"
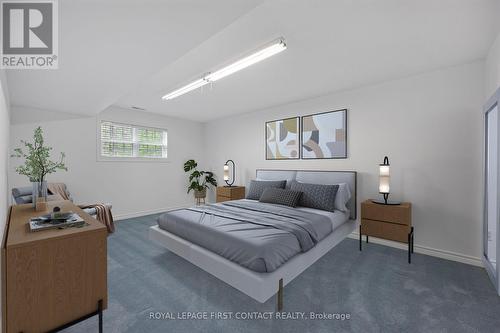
top-left (255, 169), bottom-right (357, 220)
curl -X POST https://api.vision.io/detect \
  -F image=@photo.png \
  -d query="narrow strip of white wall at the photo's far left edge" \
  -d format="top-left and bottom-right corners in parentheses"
top-left (0, 71), bottom-right (10, 239)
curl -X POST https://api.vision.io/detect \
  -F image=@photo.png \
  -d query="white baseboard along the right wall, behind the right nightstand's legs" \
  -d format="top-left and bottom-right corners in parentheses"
top-left (348, 232), bottom-right (484, 267)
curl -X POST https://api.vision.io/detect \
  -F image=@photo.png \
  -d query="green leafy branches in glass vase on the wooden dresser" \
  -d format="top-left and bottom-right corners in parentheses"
top-left (12, 127), bottom-right (68, 207)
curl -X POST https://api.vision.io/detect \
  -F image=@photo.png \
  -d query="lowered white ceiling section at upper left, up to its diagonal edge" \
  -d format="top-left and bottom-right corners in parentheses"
top-left (7, 0), bottom-right (263, 114)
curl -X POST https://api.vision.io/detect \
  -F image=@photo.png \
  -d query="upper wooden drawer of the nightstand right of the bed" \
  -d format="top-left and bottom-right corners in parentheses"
top-left (361, 202), bottom-right (411, 225)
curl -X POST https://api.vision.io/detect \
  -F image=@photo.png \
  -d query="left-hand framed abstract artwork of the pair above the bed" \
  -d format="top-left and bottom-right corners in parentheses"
top-left (265, 117), bottom-right (300, 160)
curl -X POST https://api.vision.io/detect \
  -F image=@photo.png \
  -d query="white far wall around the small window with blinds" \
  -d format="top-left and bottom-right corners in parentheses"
top-left (9, 107), bottom-right (203, 218)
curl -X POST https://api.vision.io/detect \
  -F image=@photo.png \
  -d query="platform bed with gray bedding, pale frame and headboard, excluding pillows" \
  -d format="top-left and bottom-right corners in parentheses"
top-left (149, 169), bottom-right (358, 311)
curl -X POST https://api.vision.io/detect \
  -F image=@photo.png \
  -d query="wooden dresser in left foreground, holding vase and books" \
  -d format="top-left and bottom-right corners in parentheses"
top-left (2, 201), bottom-right (107, 333)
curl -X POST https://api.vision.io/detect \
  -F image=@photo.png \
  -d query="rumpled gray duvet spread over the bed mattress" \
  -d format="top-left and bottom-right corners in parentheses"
top-left (158, 200), bottom-right (332, 273)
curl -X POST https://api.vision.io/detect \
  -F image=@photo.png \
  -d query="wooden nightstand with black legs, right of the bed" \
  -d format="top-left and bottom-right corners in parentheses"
top-left (359, 200), bottom-right (413, 263)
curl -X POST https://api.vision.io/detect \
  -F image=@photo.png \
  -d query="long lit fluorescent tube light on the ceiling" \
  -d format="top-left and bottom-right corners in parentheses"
top-left (162, 38), bottom-right (286, 100)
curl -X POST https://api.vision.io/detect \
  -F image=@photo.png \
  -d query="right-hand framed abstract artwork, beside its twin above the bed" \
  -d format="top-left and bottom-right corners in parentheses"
top-left (300, 109), bottom-right (347, 160)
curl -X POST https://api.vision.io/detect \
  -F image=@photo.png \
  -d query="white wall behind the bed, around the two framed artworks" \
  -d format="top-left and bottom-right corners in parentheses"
top-left (205, 62), bottom-right (484, 263)
